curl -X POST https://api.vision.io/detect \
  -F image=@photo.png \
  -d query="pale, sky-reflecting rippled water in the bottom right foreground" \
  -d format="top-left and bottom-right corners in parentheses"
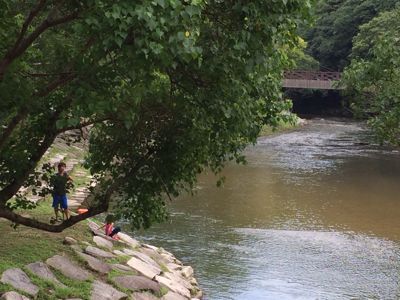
top-left (235, 228), bottom-right (400, 299)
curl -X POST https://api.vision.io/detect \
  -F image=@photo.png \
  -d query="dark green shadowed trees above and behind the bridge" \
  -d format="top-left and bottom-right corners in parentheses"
top-left (305, 0), bottom-right (399, 71)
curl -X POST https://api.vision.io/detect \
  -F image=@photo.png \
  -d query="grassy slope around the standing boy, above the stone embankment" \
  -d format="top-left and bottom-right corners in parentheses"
top-left (0, 141), bottom-right (92, 274)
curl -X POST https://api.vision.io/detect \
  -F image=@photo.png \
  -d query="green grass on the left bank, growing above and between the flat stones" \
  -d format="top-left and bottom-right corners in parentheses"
top-left (0, 199), bottom-right (97, 300)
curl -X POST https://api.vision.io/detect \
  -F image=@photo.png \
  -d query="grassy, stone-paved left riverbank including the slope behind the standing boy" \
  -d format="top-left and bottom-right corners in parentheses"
top-left (0, 137), bottom-right (202, 300)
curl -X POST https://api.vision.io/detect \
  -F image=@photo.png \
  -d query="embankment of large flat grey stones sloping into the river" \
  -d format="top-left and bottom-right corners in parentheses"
top-left (0, 221), bottom-right (202, 300)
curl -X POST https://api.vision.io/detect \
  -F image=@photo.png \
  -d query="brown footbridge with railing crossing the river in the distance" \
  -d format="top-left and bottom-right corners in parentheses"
top-left (282, 70), bottom-right (343, 90)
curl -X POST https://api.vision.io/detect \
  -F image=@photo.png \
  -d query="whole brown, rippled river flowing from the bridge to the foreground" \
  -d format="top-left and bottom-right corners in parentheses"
top-left (134, 119), bottom-right (400, 300)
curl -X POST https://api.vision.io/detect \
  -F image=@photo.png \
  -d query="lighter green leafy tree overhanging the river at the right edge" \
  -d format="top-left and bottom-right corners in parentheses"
top-left (343, 7), bottom-right (400, 145)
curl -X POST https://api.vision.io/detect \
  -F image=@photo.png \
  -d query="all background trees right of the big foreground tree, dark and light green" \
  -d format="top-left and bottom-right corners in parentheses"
top-left (299, 0), bottom-right (400, 145)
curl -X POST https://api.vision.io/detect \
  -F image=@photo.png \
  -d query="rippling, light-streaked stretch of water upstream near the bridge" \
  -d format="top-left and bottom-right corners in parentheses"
top-left (253, 120), bottom-right (394, 175)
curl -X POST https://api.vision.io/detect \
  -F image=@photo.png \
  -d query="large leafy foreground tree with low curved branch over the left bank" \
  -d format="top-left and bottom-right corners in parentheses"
top-left (0, 0), bottom-right (311, 232)
